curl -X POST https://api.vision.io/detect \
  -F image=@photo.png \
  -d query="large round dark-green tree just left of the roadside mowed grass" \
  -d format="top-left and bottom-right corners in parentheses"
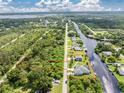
top-left (28, 68), bottom-right (52, 93)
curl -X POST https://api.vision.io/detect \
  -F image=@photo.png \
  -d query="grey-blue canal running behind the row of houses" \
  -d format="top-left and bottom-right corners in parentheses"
top-left (73, 22), bottom-right (121, 93)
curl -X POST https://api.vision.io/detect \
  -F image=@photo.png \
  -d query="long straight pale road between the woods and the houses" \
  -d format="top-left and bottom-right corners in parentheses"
top-left (62, 23), bottom-right (68, 93)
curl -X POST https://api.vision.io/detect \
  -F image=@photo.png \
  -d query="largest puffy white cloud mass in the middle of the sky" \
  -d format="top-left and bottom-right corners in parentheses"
top-left (35, 0), bottom-right (104, 11)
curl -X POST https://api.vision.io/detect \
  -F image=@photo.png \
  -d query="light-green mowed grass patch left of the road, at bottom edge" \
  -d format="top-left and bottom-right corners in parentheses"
top-left (50, 79), bottom-right (63, 93)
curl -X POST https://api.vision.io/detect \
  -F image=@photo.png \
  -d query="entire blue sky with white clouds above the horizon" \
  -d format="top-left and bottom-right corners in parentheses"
top-left (0, 0), bottom-right (124, 13)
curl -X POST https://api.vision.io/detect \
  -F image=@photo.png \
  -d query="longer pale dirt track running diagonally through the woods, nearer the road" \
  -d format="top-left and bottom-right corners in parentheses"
top-left (0, 31), bottom-right (49, 85)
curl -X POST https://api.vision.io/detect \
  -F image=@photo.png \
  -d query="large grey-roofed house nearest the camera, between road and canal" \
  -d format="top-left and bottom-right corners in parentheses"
top-left (74, 65), bottom-right (90, 76)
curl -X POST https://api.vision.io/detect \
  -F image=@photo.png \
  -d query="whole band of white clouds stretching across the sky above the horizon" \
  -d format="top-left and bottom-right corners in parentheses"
top-left (0, 0), bottom-right (122, 13)
